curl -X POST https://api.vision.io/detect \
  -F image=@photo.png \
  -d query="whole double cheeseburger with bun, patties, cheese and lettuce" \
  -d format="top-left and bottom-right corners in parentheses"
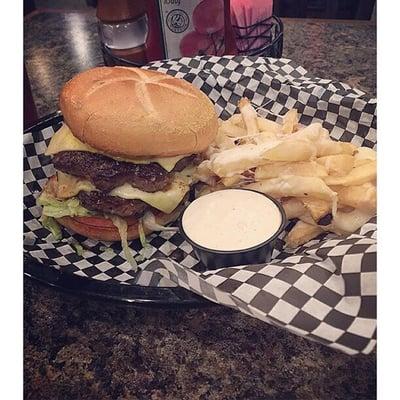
top-left (38, 67), bottom-right (218, 260)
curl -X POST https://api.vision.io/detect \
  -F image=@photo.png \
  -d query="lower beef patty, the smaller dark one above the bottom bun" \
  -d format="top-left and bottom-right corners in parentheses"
top-left (78, 191), bottom-right (150, 218)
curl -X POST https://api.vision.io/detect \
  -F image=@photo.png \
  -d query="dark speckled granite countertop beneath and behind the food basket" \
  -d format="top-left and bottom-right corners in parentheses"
top-left (24, 12), bottom-right (376, 400)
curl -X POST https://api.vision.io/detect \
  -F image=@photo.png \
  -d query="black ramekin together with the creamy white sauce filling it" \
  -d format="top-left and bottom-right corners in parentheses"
top-left (180, 189), bottom-right (286, 269)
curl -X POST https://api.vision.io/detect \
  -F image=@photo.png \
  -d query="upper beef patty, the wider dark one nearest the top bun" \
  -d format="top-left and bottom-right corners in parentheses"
top-left (53, 151), bottom-right (199, 192)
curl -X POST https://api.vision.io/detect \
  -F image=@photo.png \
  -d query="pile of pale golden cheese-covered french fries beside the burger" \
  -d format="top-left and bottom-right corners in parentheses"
top-left (197, 98), bottom-right (376, 247)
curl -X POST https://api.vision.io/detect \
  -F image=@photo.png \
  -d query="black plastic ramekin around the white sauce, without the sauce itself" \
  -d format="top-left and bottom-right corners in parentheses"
top-left (179, 188), bottom-right (287, 269)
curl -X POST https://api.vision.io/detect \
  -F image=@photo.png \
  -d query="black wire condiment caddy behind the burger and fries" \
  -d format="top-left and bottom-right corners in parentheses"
top-left (101, 15), bottom-right (283, 67)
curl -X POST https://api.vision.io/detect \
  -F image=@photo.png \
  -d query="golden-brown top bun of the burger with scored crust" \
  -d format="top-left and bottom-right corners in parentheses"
top-left (60, 67), bottom-right (218, 158)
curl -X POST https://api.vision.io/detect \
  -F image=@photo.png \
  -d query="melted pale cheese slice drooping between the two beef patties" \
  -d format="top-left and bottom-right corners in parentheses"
top-left (110, 177), bottom-right (189, 214)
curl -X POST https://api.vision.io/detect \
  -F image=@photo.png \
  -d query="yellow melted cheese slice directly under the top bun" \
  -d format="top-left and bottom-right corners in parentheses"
top-left (45, 124), bottom-right (187, 172)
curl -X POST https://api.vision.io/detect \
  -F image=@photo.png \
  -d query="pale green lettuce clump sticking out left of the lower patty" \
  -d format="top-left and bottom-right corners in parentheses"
top-left (37, 192), bottom-right (91, 218)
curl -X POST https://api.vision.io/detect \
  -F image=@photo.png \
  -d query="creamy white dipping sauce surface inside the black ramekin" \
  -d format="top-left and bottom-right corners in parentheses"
top-left (182, 189), bottom-right (282, 251)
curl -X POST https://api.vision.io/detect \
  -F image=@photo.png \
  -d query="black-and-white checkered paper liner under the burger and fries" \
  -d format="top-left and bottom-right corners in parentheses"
top-left (24, 56), bottom-right (376, 354)
